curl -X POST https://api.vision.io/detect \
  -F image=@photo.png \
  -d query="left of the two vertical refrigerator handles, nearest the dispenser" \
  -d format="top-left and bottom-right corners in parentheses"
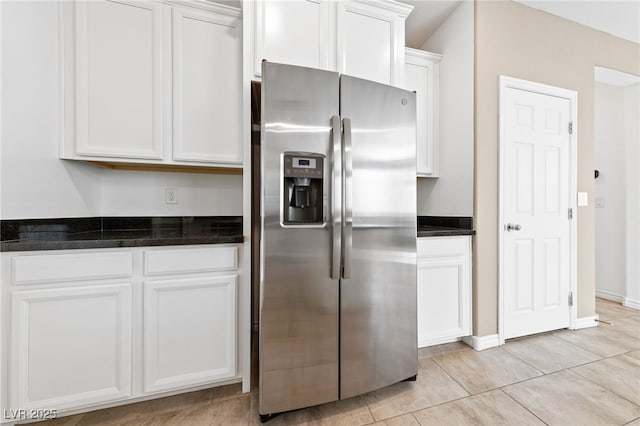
top-left (331, 115), bottom-right (342, 279)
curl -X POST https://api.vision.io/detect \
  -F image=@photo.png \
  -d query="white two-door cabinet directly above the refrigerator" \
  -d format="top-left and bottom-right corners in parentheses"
top-left (254, 0), bottom-right (412, 86)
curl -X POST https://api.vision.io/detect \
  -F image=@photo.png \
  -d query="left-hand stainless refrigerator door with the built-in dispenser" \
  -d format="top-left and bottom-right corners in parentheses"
top-left (259, 62), bottom-right (341, 415)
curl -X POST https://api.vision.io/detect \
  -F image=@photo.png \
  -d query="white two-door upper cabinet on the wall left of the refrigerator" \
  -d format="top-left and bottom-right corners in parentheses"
top-left (61, 0), bottom-right (242, 167)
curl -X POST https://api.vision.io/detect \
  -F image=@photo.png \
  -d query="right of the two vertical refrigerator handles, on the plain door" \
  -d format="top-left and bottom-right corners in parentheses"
top-left (342, 118), bottom-right (353, 278)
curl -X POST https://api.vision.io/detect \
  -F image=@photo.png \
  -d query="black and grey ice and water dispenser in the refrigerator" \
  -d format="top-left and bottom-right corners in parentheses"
top-left (282, 152), bottom-right (324, 225)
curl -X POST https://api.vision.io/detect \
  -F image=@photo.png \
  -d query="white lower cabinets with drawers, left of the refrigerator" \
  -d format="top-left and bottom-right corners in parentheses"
top-left (0, 244), bottom-right (241, 423)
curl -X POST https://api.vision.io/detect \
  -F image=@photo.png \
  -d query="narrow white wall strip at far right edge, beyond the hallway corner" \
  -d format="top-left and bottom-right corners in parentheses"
top-left (623, 84), bottom-right (640, 309)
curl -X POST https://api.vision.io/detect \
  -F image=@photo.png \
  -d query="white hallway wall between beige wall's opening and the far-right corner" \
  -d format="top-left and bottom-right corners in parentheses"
top-left (594, 83), bottom-right (627, 302)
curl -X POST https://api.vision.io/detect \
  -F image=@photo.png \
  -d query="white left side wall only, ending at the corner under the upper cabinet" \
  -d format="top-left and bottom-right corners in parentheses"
top-left (0, 1), bottom-right (100, 219)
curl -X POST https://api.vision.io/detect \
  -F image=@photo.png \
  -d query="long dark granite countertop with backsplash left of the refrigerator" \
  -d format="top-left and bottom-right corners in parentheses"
top-left (0, 216), bottom-right (243, 252)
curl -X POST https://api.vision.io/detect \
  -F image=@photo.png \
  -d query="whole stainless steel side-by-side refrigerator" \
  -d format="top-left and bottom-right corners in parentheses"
top-left (258, 62), bottom-right (418, 420)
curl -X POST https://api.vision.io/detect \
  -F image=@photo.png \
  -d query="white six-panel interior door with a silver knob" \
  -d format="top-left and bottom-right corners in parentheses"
top-left (501, 78), bottom-right (573, 339)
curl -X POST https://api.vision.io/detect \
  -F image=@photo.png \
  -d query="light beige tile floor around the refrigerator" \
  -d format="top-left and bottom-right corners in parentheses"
top-left (49, 299), bottom-right (640, 426)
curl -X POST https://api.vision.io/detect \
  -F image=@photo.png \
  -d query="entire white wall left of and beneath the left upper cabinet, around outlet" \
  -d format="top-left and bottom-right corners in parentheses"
top-left (0, 1), bottom-right (242, 219)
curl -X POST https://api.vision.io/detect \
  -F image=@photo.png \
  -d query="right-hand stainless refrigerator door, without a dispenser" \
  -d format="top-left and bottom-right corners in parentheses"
top-left (340, 75), bottom-right (418, 399)
